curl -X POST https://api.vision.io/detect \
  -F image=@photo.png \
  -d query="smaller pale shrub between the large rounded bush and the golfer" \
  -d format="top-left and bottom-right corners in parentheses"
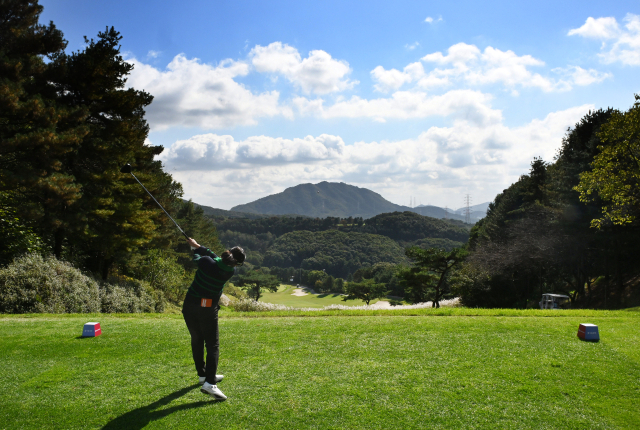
top-left (100, 277), bottom-right (164, 313)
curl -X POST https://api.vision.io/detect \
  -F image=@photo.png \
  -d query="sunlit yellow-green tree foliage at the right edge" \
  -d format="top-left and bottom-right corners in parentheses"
top-left (575, 94), bottom-right (640, 228)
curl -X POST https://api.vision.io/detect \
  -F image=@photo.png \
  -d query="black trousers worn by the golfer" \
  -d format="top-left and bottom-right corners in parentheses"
top-left (182, 300), bottom-right (220, 385)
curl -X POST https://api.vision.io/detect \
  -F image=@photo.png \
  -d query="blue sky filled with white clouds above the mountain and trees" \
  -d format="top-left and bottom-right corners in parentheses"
top-left (41, 0), bottom-right (640, 209)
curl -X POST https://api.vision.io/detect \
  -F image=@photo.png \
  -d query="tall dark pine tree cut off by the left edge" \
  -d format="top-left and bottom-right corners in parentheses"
top-left (0, 0), bottom-right (87, 258)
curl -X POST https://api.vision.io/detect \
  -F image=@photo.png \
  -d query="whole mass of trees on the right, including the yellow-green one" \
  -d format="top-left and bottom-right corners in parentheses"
top-left (458, 107), bottom-right (640, 308)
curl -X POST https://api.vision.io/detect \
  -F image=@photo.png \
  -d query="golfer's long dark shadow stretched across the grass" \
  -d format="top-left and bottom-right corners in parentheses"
top-left (102, 384), bottom-right (215, 430)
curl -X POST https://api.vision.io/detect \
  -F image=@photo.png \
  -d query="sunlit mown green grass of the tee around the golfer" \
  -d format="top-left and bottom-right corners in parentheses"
top-left (0, 308), bottom-right (640, 429)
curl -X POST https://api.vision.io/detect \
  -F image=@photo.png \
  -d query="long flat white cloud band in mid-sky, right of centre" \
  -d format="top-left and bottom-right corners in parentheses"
top-left (293, 90), bottom-right (502, 124)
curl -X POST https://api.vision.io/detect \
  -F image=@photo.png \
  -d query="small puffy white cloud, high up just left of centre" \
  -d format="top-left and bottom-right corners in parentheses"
top-left (249, 42), bottom-right (358, 94)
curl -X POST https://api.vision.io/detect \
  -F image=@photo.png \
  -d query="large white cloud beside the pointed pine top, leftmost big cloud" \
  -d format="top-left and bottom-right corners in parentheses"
top-left (127, 54), bottom-right (291, 130)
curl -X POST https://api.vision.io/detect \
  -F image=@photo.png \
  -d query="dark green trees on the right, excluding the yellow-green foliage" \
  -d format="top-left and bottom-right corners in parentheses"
top-left (464, 105), bottom-right (640, 308)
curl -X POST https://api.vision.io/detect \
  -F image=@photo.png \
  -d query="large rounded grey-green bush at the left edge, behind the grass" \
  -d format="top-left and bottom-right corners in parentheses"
top-left (0, 254), bottom-right (100, 313)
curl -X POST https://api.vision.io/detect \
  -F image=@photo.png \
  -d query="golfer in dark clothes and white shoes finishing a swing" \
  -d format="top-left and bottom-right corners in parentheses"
top-left (182, 238), bottom-right (246, 400)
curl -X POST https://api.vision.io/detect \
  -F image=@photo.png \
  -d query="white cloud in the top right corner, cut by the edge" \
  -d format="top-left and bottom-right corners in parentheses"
top-left (567, 13), bottom-right (640, 66)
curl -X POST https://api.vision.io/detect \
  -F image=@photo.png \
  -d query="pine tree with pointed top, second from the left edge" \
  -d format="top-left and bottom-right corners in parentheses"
top-left (57, 27), bottom-right (182, 277)
